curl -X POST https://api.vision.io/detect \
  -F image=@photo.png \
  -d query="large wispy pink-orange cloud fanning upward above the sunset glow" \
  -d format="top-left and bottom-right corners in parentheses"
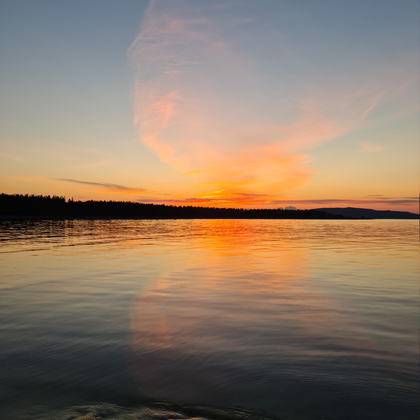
top-left (129, 0), bottom-right (414, 204)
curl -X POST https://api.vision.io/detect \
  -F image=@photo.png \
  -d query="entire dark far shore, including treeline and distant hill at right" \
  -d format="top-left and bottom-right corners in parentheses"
top-left (0, 193), bottom-right (419, 220)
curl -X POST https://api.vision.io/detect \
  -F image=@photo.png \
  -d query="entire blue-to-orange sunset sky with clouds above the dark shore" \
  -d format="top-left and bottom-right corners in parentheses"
top-left (0, 0), bottom-right (420, 213)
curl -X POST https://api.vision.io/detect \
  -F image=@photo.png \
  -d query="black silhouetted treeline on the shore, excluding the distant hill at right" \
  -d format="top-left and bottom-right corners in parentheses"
top-left (0, 194), bottom-right (345, 219)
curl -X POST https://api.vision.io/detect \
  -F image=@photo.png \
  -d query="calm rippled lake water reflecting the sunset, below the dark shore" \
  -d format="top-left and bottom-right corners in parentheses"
top-left (0, 220), bottom-right (419, 420)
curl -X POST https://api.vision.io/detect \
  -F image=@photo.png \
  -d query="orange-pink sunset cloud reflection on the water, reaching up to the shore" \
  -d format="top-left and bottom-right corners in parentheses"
top-left (131, 220), bottom-right (410, 403)
